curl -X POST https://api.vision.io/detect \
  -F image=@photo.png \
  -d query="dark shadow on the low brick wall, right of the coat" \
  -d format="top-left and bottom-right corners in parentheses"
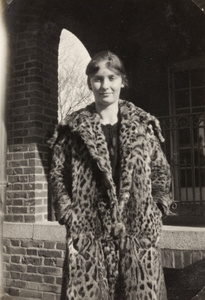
top-left (164, 258), bottom-right (205, 300)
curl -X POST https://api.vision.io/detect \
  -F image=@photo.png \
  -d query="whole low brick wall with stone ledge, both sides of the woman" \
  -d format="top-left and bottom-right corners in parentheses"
top-left (3, 222), bottom-right (205, 300)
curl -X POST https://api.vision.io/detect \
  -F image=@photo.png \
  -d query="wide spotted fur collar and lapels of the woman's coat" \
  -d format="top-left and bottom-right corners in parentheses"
top-left (50, 100), bottom-right (164, 222)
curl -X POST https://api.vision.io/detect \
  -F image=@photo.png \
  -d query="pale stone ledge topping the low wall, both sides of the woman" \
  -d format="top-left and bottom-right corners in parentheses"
top-left (3, 221), bottom-right (205, 250)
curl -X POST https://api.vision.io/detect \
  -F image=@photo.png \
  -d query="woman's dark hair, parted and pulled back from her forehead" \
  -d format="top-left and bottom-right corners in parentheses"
top-left (85, 50), bottom-right (128, 88)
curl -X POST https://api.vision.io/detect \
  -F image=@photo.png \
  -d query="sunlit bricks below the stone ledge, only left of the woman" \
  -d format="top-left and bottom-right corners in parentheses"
top-left (4, 239), bottom-right (65, 300)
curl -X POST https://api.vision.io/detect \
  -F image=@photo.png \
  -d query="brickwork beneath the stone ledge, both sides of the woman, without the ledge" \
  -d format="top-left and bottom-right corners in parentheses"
top-left (4, 238), bottom-right (205, 300)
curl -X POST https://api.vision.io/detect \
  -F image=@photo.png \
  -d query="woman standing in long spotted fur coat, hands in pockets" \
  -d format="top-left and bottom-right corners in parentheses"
top-left (50, 51), bottom-right (171, 300)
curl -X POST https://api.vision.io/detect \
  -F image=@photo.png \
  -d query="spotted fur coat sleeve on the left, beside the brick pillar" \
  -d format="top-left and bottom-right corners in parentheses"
top-left (49, 128), bottom-right (72, 225)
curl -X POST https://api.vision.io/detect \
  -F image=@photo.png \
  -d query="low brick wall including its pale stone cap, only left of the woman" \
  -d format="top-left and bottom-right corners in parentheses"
top-left (3, 222), bottom-right (66, 300)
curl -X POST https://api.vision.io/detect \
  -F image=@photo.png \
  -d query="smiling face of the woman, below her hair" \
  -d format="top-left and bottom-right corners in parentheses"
top-left (90, 62), bottom-right (124, 107)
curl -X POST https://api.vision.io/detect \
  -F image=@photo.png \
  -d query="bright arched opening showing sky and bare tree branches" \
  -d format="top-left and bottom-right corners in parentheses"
top-left (58, 29), bottom-right (93, 120)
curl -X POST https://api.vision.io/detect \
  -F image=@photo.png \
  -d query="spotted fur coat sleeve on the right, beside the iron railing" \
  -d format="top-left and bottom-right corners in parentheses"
top-left (151, 126), bottom-right (172, 215)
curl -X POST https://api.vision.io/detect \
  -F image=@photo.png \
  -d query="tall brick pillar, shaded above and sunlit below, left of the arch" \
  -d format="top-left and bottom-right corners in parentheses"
top-left (5, 1), bottom-right (61, 222)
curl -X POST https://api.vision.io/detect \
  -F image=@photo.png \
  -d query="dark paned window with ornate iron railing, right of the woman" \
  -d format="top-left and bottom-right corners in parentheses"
top-left (160, 58), bottom-right (205, 225)
